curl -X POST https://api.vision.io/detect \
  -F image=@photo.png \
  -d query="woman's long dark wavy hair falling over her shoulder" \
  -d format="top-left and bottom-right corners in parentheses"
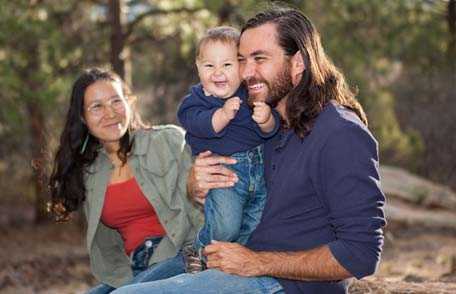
top-left (48, 68), bottom-right (145, 221)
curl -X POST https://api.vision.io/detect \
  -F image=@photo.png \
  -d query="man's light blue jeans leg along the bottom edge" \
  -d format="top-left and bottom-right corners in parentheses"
top-left (112, 270), bottom-right (285, 294)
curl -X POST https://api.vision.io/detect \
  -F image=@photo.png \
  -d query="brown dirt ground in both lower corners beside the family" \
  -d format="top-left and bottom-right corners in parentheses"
top-left (0, 217), bottom-right (456, 294)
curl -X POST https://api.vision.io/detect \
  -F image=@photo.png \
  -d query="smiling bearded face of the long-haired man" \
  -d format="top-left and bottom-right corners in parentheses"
top-left (238, 23), bottom-right (293, 107)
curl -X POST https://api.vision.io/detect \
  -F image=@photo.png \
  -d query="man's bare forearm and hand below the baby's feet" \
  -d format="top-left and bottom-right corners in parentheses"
top-left (204, 242), bottom-right (352, 281)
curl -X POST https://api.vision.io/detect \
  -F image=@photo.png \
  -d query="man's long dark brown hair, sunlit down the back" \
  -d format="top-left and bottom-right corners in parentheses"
top-left (241, 7), bottom-right (367, 137)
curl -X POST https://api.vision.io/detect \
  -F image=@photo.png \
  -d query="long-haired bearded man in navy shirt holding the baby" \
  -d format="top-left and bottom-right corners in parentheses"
top-left (111, 5), bottom-right (385, 293)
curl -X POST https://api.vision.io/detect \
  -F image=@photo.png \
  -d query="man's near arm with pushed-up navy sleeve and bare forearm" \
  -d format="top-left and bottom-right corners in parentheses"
top-left (201, 126), bottom-right (385, 281)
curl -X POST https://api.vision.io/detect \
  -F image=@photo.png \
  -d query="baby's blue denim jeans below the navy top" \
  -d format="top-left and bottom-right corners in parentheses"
top-left (194, 145), bottom-right (266, 251)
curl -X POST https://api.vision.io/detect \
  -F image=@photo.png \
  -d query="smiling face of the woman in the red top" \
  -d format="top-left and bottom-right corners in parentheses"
top-left (84, 81), bottom-right (131, 148)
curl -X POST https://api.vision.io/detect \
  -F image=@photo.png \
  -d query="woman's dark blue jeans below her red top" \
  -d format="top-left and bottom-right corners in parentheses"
top-left (87, 237), bottom-right (185, 294)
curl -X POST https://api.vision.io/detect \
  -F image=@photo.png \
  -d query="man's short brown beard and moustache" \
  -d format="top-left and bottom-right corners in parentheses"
top-left (246, 64), bottom-right (293, 108)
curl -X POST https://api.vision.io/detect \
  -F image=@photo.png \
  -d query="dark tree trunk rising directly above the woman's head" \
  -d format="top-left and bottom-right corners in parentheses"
top-left (109, 0), bottom-right (131, 85)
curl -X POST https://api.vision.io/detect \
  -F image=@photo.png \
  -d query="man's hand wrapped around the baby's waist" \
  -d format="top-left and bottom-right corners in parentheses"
top-left (187, 151), bottom-right (238, 204)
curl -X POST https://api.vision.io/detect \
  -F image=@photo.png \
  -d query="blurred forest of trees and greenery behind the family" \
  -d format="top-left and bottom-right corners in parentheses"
top-left (0, 0), bottom-right (456, 289)
